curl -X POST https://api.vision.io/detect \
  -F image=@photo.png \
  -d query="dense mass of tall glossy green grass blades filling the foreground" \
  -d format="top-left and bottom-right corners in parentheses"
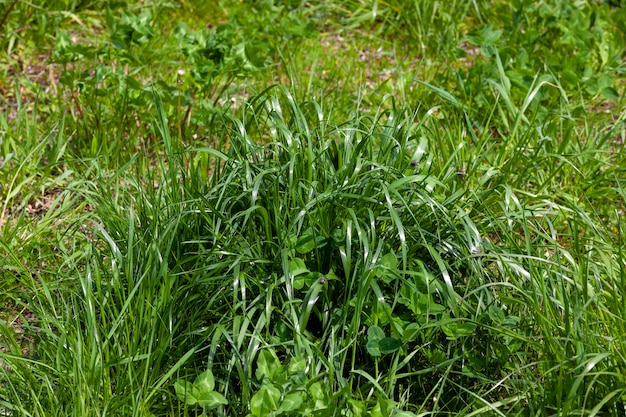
top-left (0, 83), bottom-right (626, 416)
